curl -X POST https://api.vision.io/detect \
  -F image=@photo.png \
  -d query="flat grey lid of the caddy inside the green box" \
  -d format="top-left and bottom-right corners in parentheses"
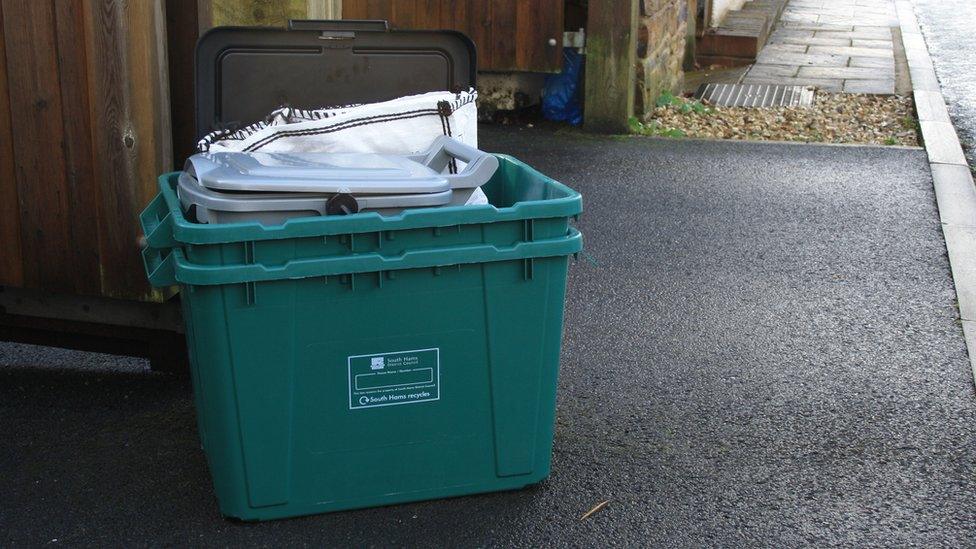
top-left (185, 152), bottom-right (451, 195)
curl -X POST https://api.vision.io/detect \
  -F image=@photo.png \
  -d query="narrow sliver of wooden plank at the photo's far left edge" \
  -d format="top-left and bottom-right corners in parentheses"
top-left (0, 1), bottom-right (24, 286)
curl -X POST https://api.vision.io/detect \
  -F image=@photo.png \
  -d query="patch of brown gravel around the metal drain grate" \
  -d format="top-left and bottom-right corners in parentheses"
top-left (644, 91), bottom-right (919, 146)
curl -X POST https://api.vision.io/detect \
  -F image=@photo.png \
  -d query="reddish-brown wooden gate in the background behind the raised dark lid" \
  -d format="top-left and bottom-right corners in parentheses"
top-left (342, 0), bottom-right (565, 72)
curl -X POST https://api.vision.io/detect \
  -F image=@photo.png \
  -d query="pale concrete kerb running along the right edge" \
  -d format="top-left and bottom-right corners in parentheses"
top-left (895, 0), bottom-right (976, 384)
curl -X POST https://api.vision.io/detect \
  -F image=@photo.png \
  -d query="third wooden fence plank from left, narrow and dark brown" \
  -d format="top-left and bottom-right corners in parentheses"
top-left (54, 2), bottom-right (101, 295)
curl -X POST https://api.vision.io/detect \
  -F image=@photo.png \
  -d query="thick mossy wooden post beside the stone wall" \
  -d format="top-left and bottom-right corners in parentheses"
top-left (584, 0), bottom-right (639, 133)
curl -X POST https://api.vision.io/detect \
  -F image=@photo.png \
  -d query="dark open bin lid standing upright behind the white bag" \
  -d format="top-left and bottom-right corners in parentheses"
top-left (195, 20), bottom-right (476, 138)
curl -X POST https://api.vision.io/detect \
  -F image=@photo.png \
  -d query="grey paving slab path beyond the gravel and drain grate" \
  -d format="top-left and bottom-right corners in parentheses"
top-left (742, 0), bottom-right (907, 94)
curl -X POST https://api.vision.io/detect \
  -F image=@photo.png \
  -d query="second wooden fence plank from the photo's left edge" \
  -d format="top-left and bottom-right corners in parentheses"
top-left (3, 0), bottom-right (74, 292)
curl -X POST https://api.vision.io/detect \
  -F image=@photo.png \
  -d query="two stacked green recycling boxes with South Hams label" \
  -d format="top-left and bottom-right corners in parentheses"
top-left (142, 156), bottom-right (582, 520)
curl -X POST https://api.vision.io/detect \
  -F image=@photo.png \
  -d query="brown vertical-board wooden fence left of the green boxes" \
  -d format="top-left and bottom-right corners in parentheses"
top-left (0, 0), bottom-right (172, 300)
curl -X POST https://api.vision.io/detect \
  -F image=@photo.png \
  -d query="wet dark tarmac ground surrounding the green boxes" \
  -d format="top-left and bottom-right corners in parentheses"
top-left (0, 127), bottom-right (976, 547)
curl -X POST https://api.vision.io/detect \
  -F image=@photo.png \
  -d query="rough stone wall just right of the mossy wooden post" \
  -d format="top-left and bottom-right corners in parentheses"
top-left (634, 0), bottom-right (692, 117)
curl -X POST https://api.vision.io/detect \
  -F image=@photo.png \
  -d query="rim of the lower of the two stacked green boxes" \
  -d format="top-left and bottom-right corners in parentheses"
top-left (149, 228), bottom-right (583, 286)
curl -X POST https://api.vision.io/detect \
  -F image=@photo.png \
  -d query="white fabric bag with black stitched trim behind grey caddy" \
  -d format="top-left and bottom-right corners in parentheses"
top-left (198, 88), bottom-right (488, 204)
